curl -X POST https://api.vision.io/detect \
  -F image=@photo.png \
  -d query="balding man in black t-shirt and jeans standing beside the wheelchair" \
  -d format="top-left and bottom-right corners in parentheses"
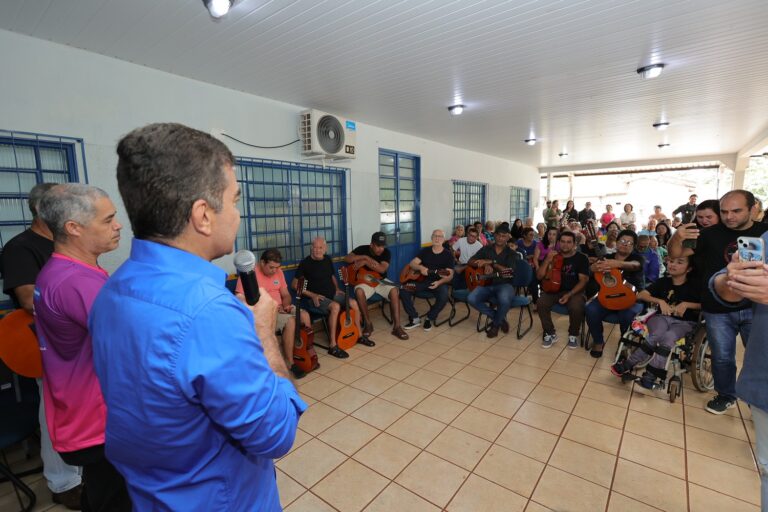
top-left (667, 190), bottom-right (768, 414)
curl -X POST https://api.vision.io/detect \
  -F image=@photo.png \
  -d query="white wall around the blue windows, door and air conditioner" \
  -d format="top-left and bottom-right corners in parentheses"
top-left (0, 30), bottom-right (539, 270)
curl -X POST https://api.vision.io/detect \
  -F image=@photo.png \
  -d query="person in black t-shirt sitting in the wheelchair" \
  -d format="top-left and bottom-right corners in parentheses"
top-left (611, 257), bottom-right (701, 389)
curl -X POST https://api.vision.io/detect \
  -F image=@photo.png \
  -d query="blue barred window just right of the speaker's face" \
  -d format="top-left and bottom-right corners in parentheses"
top-left (235, 157), bottom-right (347, 265)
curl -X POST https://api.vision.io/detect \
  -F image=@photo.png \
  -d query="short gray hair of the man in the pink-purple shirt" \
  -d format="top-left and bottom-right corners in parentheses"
top-left (38, 183), bottom-right (109, 241)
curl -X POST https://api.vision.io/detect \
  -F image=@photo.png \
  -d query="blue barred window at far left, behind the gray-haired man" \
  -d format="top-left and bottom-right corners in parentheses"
top-left (0, 130), bottom-right (87, 306)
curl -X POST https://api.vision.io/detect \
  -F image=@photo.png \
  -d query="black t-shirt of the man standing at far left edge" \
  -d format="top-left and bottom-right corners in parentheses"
top-left (0, 229), bottom-right (53, 308)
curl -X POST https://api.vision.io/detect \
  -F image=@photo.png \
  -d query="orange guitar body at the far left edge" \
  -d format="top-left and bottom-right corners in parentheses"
top-left (0, 309), bottom-right (43, 378)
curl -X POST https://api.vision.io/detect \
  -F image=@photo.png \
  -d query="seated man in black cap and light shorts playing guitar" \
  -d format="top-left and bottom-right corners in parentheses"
top-left (344, 232), bottom-right (412, 340)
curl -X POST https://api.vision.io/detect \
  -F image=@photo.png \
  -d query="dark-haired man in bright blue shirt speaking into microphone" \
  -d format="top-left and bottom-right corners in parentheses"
top-left (89, 124), bottom-right (306, 511)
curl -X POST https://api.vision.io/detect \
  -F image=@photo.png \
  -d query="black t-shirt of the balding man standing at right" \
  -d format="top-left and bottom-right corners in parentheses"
top-left (693, 222), bottom-right (768, 313)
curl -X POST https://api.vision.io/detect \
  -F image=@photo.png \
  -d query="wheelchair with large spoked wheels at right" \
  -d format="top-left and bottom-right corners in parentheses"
top-left (614, 317), bottom-right (715, 403)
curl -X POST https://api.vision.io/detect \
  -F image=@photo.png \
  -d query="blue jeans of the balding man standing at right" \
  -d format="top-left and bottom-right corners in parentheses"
top-left (704, 308), bottom-right (752, 400)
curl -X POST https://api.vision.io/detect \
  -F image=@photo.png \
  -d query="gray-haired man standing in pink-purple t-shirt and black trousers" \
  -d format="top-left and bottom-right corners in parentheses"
top-left (33, 183), bottom-right (131, 512)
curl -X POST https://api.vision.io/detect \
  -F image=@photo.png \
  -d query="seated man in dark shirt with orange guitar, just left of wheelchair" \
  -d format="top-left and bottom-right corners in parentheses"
top-left (586, 229), bottom-right (645, 357)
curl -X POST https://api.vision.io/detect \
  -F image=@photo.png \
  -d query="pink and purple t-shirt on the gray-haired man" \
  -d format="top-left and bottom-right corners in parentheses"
top-left (34, 253), bottom-right (109, 452)
